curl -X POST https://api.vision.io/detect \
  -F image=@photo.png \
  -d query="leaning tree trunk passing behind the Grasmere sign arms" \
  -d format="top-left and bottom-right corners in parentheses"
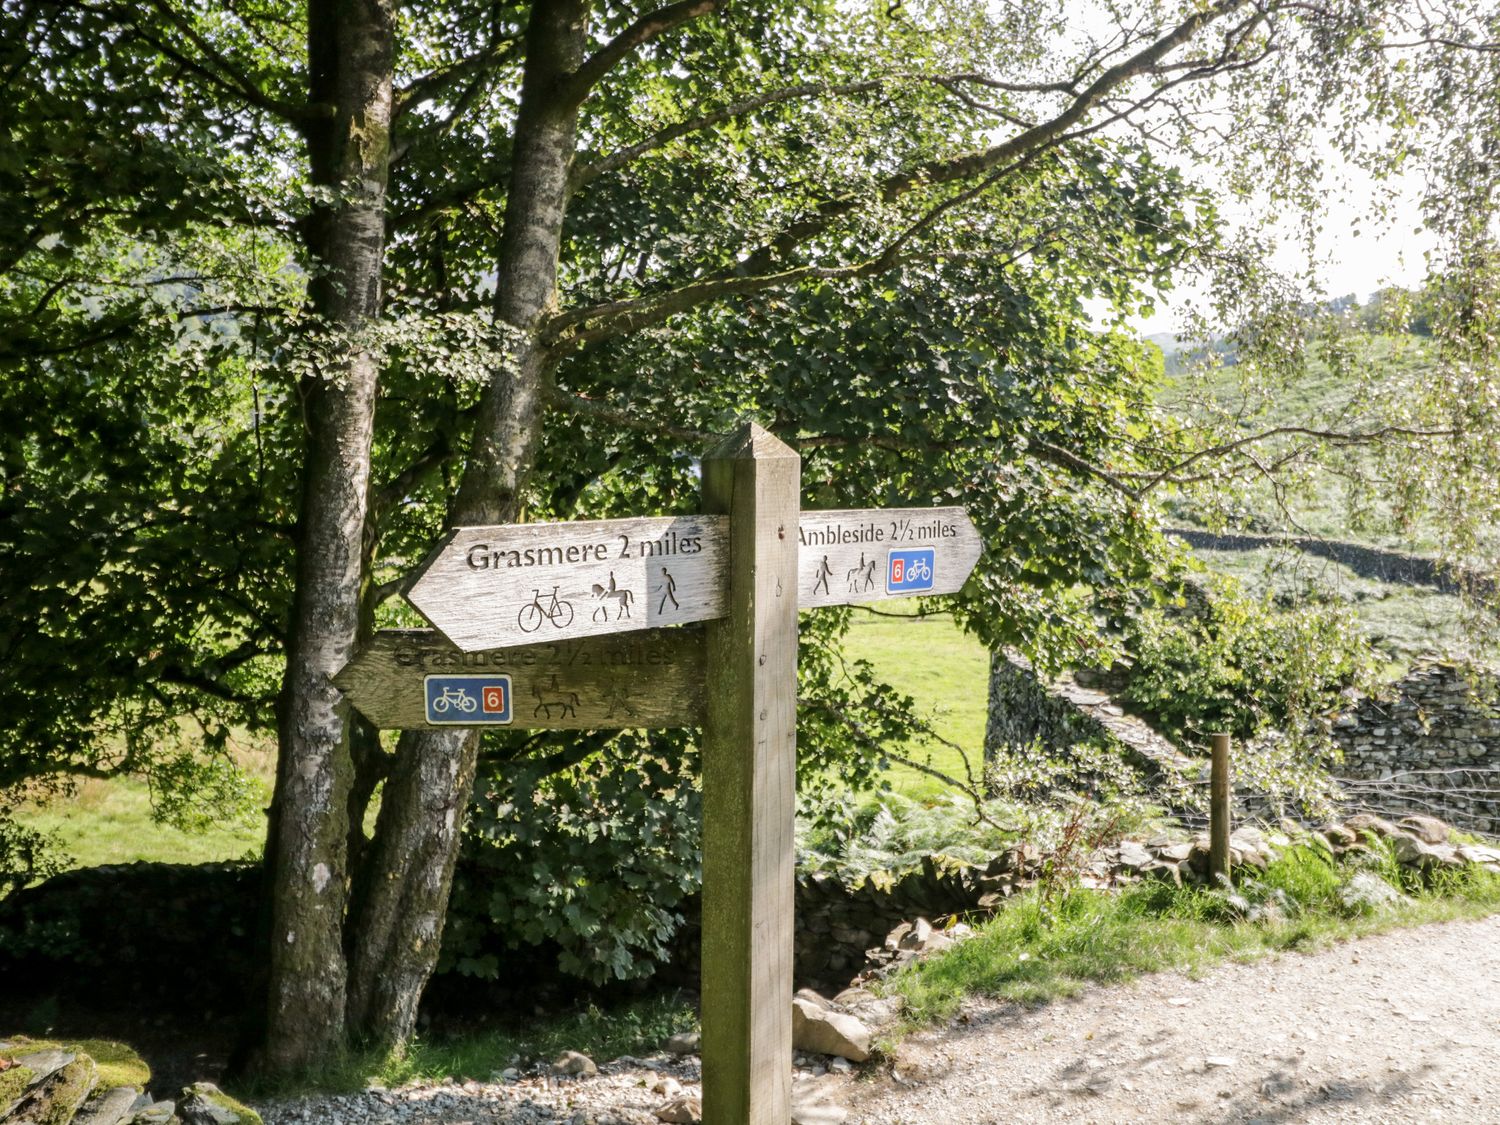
top-left (348, 0), bottom-right (587, 1044)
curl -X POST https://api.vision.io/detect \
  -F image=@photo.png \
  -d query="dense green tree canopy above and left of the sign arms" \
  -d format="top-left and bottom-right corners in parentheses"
top-left (0, 3), bottom-right (1260, 822)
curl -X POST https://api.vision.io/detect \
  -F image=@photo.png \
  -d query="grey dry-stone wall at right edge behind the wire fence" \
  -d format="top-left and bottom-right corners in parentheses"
top-left (1334, 663), bottom-right (1500, 836)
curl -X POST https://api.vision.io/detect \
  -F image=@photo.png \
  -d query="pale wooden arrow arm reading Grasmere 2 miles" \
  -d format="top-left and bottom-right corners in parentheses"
top-left (407, 516), bottom-right (726, 653)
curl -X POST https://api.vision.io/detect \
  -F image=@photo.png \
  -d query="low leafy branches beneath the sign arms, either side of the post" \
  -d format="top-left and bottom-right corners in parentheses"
top-left (444, 603), bottom-right (914, 984)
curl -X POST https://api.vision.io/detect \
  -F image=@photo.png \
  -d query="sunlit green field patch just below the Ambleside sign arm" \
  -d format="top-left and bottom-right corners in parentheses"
top-left (845, 602), bottom-right (990, 800)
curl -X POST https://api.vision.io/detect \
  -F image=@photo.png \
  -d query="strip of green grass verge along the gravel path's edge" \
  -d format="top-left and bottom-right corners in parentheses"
top-left (885, 848), bottom-right (1500, 1046)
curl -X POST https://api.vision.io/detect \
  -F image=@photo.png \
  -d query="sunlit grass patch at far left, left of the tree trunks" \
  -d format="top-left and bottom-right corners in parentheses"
top-left (17, 777), bottom-right (266, 867)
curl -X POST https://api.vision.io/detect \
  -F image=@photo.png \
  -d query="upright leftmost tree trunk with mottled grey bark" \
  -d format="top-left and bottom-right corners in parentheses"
top-left (263, 0), bottom-right (395, 1073)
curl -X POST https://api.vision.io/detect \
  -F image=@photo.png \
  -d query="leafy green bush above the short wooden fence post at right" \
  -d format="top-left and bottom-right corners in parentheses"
top-left (1124, 576), bottom-right (1374, 746)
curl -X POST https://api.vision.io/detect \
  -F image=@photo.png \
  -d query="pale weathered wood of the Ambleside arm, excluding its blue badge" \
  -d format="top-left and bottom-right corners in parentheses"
top-left (797, 507), bottom-right (984, 609)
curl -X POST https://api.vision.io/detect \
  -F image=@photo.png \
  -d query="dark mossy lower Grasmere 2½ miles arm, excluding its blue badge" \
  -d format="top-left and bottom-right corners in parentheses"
top-left (333, 626), bottom-right (704, 731)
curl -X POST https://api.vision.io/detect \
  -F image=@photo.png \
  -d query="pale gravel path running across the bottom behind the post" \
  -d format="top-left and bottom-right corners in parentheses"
top-left (266, 917), bottom-right (1500, 1125)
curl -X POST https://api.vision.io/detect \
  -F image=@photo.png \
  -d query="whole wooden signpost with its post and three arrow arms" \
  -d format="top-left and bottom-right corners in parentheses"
top-left (335, 423), bottom-right (983, 1125)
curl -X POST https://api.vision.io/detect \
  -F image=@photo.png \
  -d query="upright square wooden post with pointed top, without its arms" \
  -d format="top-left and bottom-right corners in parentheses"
top-left (702, 425), bottom-right (801, 1125)
